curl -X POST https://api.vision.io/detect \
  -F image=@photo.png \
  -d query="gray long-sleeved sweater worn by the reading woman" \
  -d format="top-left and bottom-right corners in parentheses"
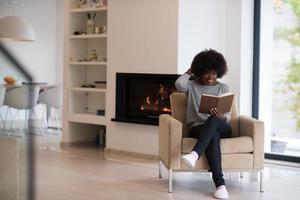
top-left (175, 73), bottom-right (231, 130)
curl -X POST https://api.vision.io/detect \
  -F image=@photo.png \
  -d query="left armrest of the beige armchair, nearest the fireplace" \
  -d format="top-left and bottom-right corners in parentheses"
top-left (159, 114), bottom-right (182, 169)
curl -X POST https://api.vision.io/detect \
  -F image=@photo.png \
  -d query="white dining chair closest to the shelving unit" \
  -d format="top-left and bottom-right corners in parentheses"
top-left (38, 86), bottom-right (63, 134)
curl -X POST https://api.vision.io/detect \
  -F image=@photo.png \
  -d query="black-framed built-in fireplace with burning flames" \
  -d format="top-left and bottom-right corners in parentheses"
top-left (112, 73), bottom-right (179, 125)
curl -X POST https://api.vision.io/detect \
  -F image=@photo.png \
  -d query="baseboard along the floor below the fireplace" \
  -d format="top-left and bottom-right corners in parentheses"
top-left (104, 148), bottom-right (159, 160)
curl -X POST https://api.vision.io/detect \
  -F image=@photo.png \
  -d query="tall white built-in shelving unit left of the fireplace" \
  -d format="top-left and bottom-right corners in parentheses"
top-left (63, 0), bottom-right (108, 144)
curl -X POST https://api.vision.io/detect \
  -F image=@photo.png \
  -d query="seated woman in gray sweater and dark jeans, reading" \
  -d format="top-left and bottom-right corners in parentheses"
top-left (175, 49), bottom-right (231, 199)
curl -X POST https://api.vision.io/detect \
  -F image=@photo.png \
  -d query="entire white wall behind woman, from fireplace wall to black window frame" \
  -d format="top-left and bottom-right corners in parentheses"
top-left (178, 0), bottom-right (253, 115)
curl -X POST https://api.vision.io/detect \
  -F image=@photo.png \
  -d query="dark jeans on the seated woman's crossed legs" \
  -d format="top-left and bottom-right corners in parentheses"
top-left (189, 116), bottom-right (231, 187)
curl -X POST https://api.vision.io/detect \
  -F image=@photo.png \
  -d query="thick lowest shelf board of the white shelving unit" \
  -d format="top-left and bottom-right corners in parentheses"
top-left (68, 113), bottom-right (106, 125)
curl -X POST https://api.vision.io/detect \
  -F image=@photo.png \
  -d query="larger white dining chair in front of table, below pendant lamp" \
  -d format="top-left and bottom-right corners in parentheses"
top-left (4, 85), bottom-right (40, 136)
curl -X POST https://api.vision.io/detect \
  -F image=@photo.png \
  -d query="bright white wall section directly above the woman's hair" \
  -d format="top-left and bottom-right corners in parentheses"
top-left (178, 0), bottom-right (226, 74)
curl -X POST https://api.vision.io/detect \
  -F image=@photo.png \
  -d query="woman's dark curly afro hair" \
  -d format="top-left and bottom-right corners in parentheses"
top-left (191, 49), bottom-right (227, 78)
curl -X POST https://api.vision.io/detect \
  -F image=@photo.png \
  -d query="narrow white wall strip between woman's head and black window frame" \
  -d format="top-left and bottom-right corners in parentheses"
top-left (224, 0), bottom-right (254, 116)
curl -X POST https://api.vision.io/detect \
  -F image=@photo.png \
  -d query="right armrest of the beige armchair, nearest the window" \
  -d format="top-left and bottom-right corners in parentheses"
top-left (238, 116), bottom-right (265, 169)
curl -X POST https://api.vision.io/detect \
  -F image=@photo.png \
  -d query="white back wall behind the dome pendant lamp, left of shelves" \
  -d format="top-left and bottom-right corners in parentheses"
top-left (0, 0), bottom-right (63, 84)
